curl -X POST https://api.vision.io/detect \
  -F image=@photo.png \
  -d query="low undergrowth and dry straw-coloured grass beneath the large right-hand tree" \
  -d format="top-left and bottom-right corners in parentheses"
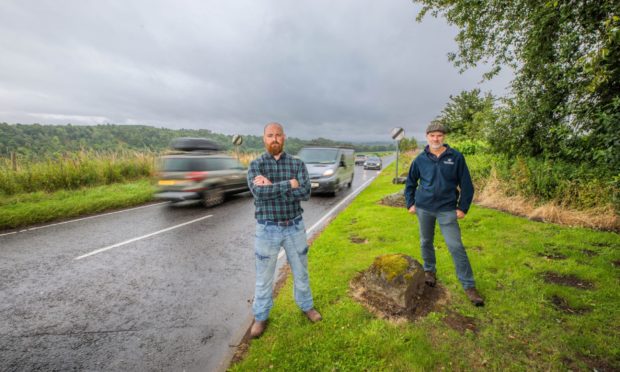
top-left (450, 140), bottom-right (620, 232)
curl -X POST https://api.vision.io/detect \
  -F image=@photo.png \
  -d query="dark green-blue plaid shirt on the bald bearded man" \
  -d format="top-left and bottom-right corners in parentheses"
top-left (248, 152), bottom-right (310, 221)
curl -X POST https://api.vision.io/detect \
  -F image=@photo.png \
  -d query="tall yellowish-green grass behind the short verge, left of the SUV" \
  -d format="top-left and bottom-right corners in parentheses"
top-left (0, 151), bottom-right (157, 196)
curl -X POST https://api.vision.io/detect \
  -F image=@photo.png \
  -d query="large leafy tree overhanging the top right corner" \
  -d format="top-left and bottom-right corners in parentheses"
top-left (414, 0), bottom-right (620, 174)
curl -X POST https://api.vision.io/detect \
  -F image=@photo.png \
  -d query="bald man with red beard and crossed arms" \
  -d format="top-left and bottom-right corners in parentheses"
top-left (248, 123), bottom-right (321, 338)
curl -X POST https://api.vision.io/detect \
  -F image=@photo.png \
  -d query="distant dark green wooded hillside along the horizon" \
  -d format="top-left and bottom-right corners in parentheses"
top-left (0, 123), bottom-right (394, 160)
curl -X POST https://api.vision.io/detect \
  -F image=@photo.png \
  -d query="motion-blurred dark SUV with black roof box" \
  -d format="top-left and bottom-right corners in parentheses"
top-left (155, 139), bottom-right (248, 207)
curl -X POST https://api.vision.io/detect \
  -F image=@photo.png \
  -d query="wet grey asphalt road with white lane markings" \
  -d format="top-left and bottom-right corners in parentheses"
top-left (0, 159), bottom-right (389, 371)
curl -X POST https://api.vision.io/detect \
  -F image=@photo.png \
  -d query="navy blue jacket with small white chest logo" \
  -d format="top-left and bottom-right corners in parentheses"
top-left (405, 145), bottom-right (474, 213)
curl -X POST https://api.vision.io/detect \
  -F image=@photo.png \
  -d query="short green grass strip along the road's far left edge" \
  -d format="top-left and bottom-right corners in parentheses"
top-left (0, 180), bottom-right (154, 230)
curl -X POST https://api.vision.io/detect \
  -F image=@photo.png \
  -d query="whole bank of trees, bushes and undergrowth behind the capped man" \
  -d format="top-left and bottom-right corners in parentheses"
top-left (414, 0), bottom-right (620, 213)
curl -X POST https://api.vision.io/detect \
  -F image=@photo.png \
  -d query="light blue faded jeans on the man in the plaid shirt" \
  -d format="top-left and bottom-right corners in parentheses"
top-left (252, 219), bottom-right (314, 321)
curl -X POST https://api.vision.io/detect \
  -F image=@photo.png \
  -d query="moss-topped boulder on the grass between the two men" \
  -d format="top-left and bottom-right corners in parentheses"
top-left (359, 253), bottom-right (425, 312)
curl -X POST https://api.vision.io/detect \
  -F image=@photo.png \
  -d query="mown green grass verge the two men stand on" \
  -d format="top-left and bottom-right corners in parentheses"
top-left (231, 161), bottom-right (620, 371)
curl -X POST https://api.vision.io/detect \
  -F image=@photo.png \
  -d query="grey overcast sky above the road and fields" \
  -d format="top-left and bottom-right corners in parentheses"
top-left (0, 0), bottom-right (511, 141)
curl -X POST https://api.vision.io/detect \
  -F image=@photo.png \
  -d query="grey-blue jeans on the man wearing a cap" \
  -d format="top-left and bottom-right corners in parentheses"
top-left (416, 207), bottom-right (476, 289)
